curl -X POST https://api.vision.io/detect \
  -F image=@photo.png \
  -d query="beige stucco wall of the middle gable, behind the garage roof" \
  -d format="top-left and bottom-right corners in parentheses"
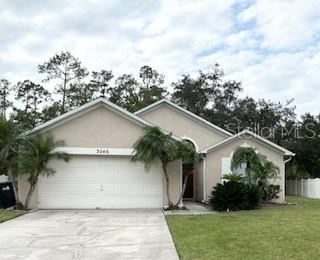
top-left (140, 105), bottom-right (226, 149)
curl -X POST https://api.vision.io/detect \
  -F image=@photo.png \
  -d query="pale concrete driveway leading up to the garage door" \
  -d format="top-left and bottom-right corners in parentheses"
top-left (0, 210), bottom-right (178, 260)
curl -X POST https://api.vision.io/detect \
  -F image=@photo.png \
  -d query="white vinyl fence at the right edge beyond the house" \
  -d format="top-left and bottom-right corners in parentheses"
top-left (286, 178), bottom-right (320, 199)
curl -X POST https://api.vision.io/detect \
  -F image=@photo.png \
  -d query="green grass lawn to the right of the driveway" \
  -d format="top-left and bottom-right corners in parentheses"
top-left (167, 197), bottom-right (320, 260)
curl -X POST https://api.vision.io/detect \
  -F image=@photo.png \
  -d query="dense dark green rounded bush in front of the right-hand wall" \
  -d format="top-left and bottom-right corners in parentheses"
top-left (209, 181), bottom-right (261, 211)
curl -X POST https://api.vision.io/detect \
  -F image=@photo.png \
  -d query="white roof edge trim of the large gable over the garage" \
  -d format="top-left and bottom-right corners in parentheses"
top-left (25, 97), bottom-right (181, 140)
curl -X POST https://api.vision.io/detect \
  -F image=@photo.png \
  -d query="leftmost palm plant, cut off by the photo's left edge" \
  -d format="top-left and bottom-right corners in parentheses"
top-left (0, 117), bottom-right (26, 208)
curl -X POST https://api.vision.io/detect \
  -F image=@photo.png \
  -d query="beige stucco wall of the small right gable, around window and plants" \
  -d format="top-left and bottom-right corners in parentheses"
top-left (205, 137), bottom-right (285, 203)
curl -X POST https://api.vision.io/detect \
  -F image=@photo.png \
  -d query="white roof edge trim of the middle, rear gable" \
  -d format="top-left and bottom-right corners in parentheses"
top-left (134, 99), bottom-right (232, 136)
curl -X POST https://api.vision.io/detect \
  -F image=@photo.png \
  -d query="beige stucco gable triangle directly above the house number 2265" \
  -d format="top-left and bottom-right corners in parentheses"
top-left (49, 104), bottom-right (144, 148)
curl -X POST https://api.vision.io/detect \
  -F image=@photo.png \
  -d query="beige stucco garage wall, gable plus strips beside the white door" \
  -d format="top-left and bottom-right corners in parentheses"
top-left (19, 106), bottom-right (181, 208)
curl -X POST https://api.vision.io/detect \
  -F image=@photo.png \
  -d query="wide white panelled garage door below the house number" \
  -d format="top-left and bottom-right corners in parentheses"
top-left (38, 156), bottom-right (162, 209)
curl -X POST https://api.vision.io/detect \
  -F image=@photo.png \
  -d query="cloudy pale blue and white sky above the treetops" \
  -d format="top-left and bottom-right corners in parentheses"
top-left (0, 0), bottom-right (320, 113)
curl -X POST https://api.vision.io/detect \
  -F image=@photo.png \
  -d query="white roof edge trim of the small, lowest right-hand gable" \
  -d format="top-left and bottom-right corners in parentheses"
top-left (201, 129), bottom-right (295, 156)
